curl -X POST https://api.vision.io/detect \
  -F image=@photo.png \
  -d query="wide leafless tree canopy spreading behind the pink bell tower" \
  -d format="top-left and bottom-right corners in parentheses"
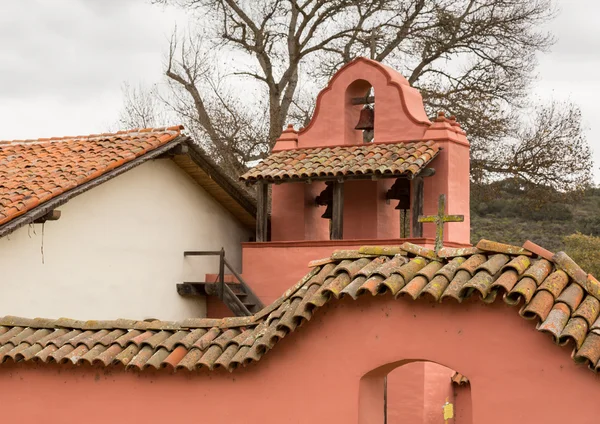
top-left (145, 0), bottom-right (589, 189)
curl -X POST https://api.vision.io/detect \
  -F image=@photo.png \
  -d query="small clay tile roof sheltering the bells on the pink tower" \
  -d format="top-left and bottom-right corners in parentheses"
top-left (240, 141), bottom-right (440, 183)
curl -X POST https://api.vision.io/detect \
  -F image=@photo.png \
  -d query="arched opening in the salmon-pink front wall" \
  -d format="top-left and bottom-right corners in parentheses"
top-left (358, 360), bottom-right (472, 424)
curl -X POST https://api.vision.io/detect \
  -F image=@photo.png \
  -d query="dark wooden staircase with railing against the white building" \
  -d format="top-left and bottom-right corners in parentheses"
top-left (177, 249), bottom-right (264, 316)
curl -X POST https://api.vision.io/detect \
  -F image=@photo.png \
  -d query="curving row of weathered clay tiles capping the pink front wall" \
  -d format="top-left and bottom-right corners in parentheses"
top-left (0, 241), bottom-right (600, 374)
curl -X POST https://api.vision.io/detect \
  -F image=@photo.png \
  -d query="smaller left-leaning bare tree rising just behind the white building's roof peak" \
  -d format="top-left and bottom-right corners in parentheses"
top-left (163, 32), bottom-right (269, 177)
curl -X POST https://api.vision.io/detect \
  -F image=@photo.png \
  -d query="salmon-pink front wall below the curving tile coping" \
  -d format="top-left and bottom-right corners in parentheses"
top-left (0, 296), bottom-right (600, 424)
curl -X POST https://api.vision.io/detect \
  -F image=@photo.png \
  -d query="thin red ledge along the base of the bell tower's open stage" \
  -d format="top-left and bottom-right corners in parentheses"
top-left (242, 238), bottom-right (472, 249)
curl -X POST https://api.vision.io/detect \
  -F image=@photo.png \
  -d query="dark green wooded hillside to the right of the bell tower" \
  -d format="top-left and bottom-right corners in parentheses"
top-left (471, 183), bottom-right (600, 252)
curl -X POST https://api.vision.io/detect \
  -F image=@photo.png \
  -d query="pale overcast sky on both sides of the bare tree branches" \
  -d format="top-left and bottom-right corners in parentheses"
top-left (0, 0), bottom-right (600, 182)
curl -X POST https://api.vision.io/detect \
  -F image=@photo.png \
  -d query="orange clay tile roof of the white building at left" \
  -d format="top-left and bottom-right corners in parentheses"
top-left (0, 126), bottom-right (183, 236)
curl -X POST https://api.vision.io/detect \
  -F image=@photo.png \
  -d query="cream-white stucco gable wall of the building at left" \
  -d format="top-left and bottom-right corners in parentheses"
top-left (0, 159), bottom-right (249, 320)
